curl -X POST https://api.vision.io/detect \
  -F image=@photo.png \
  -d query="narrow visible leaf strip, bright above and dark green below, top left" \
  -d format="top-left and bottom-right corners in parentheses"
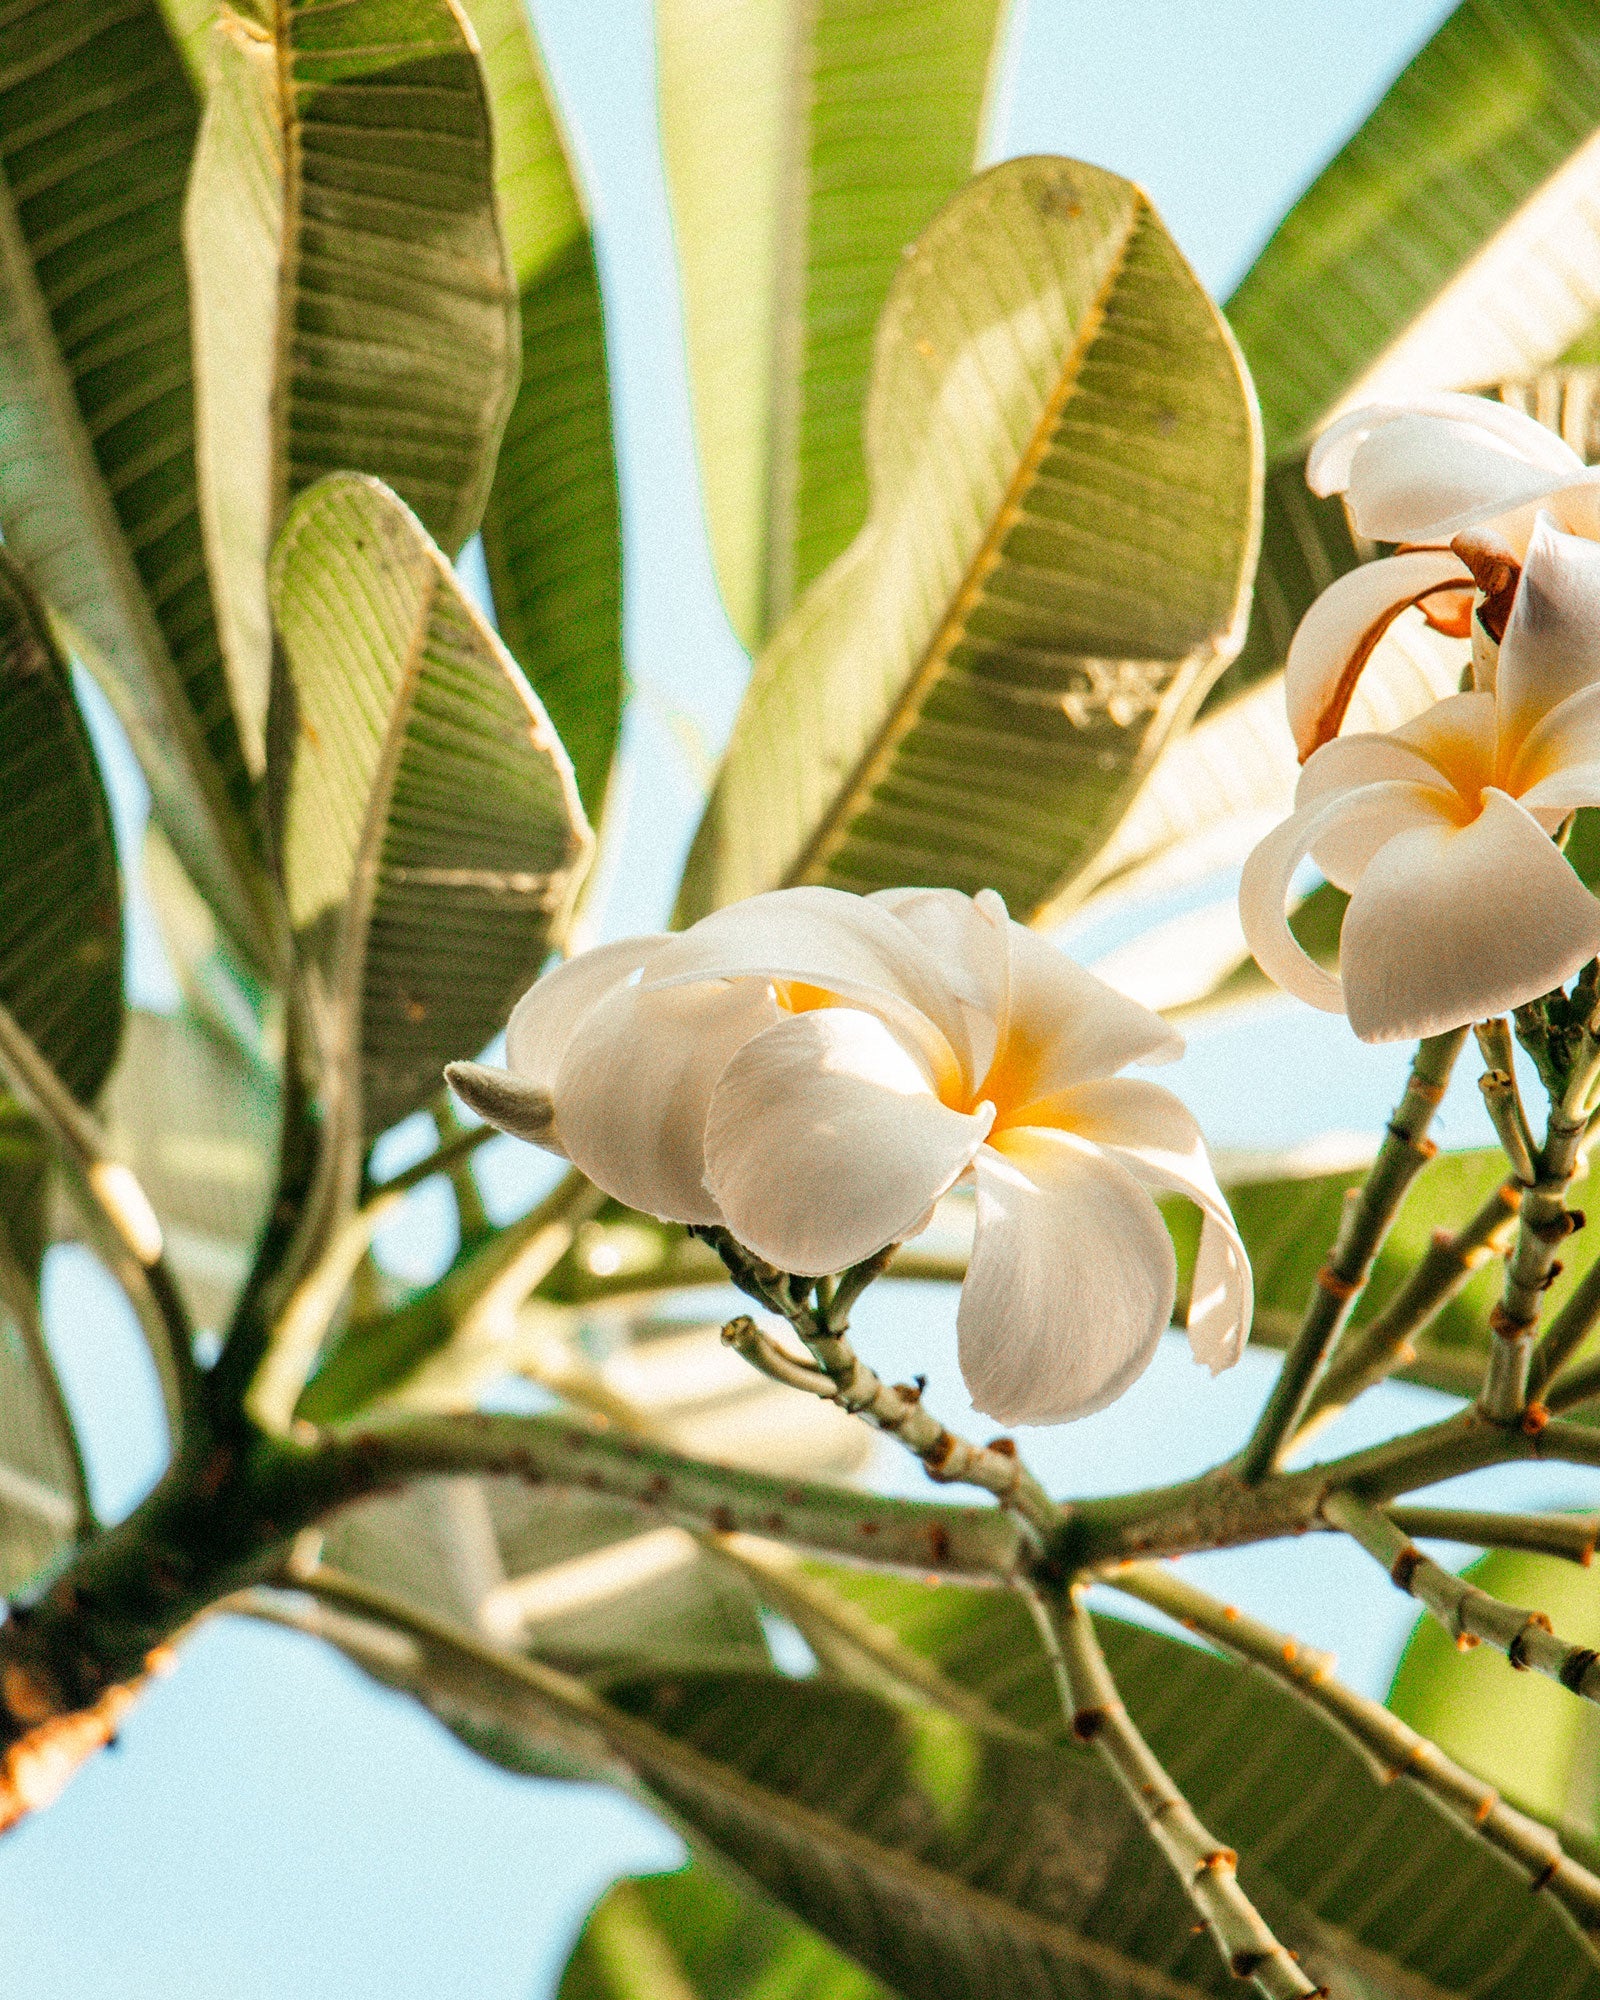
top-left (468, 0), bottom-right (622, 822)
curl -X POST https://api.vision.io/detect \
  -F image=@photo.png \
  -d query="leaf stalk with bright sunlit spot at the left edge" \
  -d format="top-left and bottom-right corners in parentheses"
top-left (0, 1006), bottom-right (208, 1450)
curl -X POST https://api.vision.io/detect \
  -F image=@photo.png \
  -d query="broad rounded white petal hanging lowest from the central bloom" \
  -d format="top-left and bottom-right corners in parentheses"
top-left (956, 1128), bottom-right (1178, 1424)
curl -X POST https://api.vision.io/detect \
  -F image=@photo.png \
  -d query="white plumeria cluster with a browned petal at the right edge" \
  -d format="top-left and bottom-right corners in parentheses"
top-left (1240, 396), bottom-right (1600, 1042)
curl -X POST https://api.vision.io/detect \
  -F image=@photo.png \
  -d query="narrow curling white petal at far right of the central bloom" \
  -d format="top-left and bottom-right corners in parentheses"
top-left (1058, 1076), bottom-right (1254, 1374)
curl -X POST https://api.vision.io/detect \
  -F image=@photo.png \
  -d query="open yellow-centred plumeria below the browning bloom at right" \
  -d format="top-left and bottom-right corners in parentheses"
top-left (1240, 516), bottom-right (1600, 1042)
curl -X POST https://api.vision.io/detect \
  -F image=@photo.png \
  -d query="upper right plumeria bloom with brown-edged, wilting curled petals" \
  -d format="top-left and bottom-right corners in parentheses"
top-left (1284, 394), bottom-right (1600, 760)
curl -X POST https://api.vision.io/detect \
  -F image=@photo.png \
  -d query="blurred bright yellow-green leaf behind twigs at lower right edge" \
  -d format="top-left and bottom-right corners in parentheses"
top-left (1388, 1550), bottom-right (1600, 1852)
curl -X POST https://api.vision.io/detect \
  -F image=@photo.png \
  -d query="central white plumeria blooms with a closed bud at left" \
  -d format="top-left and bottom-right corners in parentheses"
top-left (446, 888), bottom-right (1250, 1424)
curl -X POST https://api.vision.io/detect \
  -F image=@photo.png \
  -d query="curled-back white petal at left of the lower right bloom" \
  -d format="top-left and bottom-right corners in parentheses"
top-left (1238, 772), bottom-right (1448, 1014)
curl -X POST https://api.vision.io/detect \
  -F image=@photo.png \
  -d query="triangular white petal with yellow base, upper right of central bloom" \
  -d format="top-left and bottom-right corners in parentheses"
top-left (1000, 924), bottom-right (1184, 1104)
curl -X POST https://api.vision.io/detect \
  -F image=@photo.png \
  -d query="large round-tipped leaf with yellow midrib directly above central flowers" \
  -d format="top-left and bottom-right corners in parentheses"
top-left (678, 160), bottom-right (1260, 920)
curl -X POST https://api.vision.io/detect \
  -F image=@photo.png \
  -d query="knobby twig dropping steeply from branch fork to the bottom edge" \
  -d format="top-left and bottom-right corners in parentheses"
top-left (1022, 1588), bottom-right (1326, 2000)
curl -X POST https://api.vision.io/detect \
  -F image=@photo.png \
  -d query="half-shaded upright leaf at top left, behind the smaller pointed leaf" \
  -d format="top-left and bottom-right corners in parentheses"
top-left (184, 0), bottom-right (518, 772)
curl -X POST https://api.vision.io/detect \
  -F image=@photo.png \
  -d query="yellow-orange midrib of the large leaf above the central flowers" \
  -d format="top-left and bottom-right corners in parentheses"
top-left (782, 192), bottom-right (1150, 888)
